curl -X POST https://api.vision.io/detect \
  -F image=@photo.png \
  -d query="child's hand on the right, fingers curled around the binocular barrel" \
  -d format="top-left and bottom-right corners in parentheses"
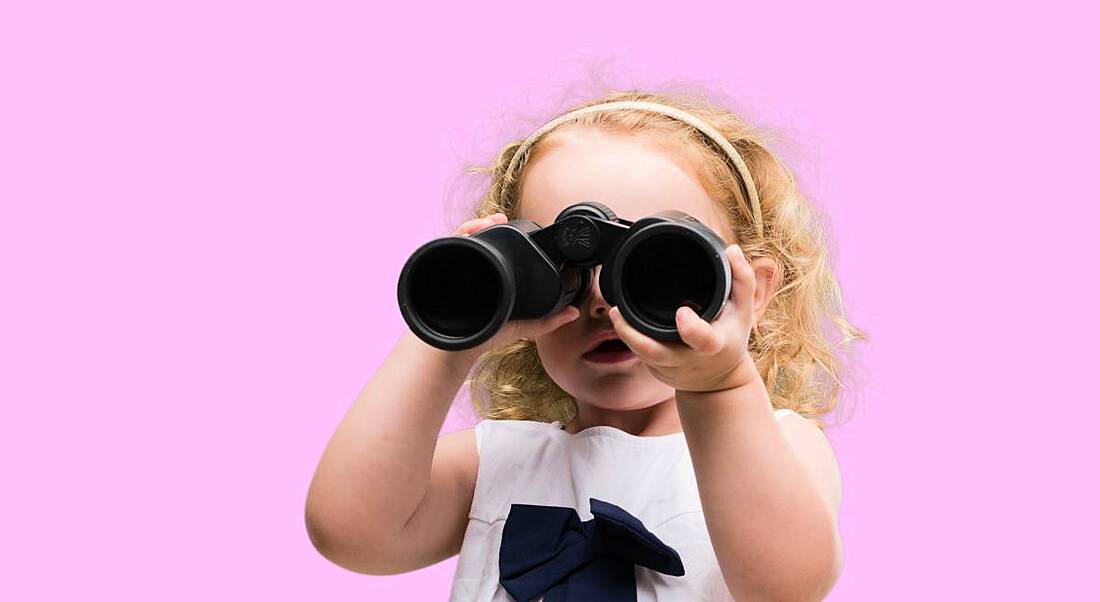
top-left (611, 244), bottom-right (756, 392)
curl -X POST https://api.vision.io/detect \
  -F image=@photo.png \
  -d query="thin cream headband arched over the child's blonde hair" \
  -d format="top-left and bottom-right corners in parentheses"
top-left (504, 100), bottom-right (763, 238)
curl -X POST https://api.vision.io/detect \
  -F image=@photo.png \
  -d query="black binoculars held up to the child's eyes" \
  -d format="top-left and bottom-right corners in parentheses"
top-left (397, 201), bottom-right (732, 351)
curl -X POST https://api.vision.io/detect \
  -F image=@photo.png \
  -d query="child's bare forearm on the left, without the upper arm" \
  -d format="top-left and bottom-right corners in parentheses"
top-left (306, 331), bottom-right (476, 555)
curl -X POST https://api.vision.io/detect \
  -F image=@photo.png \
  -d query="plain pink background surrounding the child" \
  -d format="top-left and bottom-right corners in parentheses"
top-left (0, 1), bottom-right (1100, 601)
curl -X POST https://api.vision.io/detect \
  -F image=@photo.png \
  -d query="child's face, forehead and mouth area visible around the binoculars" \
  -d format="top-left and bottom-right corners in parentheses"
top-left (517, 128), bottom-right (737, 411)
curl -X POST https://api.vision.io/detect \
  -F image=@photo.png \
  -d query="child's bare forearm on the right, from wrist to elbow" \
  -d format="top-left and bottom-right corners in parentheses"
top-left (677, 362), bottom-right (840, 600)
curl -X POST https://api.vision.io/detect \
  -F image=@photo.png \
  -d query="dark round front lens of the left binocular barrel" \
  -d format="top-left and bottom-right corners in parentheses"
top-left (409, 244), bottom-right (504, 337)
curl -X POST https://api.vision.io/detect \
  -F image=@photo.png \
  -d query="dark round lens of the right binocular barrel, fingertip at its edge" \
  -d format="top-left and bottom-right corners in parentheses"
top-left (623, 233), bottom-right (718, 328)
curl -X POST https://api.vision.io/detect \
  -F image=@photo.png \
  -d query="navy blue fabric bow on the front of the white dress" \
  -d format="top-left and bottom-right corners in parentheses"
top-left (501, 497), bottom-right (684, 602)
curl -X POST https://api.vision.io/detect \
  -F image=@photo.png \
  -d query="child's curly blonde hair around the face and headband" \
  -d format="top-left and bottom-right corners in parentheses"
top-left (451, 90), bottom-right (867, 429)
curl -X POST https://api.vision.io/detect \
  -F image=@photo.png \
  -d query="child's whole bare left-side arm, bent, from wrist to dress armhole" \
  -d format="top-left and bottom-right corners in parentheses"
top-left (306, 331), bottom-right (477, 574)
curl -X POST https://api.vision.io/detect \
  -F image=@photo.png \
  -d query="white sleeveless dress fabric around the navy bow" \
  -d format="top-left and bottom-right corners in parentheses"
top-left (451, 409), bottom-right (796, 602)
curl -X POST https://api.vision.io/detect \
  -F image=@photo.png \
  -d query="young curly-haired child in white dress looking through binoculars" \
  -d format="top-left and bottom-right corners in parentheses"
top-left (306, 91), bottom-right (865, 602)
